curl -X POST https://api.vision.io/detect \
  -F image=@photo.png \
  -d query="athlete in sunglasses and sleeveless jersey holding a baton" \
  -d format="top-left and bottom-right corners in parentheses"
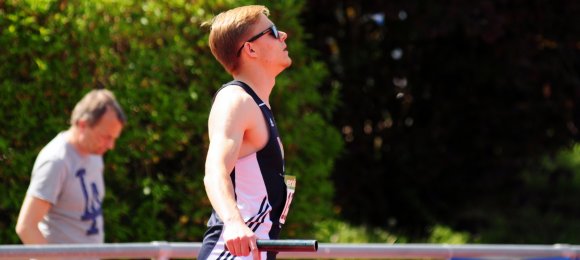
top-left (198, 6), bottom-right (295, 259)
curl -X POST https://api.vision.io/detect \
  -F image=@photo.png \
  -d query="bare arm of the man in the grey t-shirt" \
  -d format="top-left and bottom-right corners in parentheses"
top-left (16, 196), bottom-right (52, 244)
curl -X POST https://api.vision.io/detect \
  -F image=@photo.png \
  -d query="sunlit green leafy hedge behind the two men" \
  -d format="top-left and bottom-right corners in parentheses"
top-left (0, 0), bottom-right (342, 244)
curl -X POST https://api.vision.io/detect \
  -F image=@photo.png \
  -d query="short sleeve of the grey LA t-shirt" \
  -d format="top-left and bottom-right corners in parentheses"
top-left (26, 160), bottom-right (66, 204)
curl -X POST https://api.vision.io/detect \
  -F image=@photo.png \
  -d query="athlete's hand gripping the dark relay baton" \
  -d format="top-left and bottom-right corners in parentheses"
top-left (224, 223), bottom-right (261, 260)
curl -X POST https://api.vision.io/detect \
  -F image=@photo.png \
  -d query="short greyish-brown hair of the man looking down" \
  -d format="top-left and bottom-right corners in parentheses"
top-left (70, 89), bottom-right (127, 127)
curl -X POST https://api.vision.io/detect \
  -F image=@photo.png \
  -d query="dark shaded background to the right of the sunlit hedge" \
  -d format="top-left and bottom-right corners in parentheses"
top-left (303, 0), bottom-right (580, 243)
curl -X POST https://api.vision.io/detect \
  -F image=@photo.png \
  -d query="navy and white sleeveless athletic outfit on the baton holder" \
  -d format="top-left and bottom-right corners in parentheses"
top-left (198, 81), bottom-right (289, 260)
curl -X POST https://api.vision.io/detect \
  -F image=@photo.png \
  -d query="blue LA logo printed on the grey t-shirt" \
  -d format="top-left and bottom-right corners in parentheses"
top-left (76, 169), bottom-right (103, 236)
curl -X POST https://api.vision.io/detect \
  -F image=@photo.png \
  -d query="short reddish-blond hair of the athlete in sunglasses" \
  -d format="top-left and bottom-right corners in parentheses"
top-left (204, 5), bottom-right (270, 74)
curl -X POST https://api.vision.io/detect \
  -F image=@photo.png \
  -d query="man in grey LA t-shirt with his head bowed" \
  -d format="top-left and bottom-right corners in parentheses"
top-left (16, 89), bottom-right (126, 244)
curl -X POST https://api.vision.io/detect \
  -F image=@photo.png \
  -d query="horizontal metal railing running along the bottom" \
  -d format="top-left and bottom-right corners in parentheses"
top-left (0, 241), bottom-right (580, 260)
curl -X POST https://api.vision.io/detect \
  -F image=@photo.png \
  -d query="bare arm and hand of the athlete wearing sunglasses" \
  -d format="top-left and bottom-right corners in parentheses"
top-left (204, 88), bottom-right (259, 259)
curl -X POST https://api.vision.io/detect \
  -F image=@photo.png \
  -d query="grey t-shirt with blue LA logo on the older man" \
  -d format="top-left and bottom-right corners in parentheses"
top-left (27, 131), bottom-right (105, 244)
